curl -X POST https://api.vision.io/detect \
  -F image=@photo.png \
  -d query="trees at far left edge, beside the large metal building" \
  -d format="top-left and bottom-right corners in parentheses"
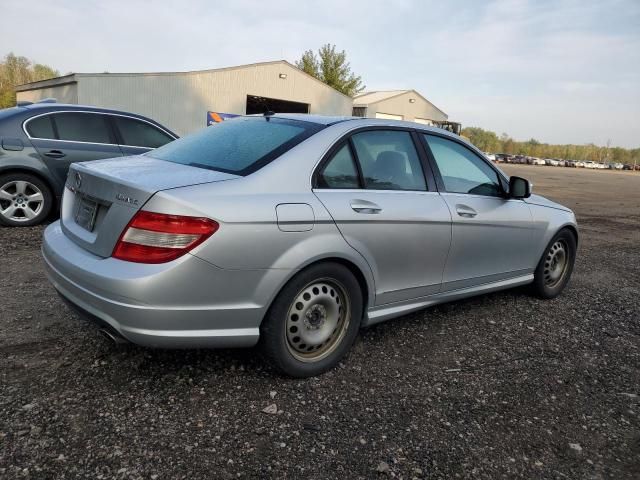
top-left (0, 52), bottom-right (60, 108)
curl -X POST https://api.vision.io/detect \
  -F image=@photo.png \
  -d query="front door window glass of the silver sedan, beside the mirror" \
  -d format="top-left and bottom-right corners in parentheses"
top-left (425, 135), bottom-right (502, 197)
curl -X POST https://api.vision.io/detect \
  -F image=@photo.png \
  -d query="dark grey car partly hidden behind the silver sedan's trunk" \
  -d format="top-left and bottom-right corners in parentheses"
top-left (0, 102), bottom-right (177, 227)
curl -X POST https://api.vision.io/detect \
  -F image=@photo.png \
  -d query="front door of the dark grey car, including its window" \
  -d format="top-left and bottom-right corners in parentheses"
top-left (110, 115), bottom-right (175, 155)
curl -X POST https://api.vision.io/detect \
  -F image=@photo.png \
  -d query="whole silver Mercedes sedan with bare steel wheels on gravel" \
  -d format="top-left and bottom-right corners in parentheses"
top-left (42, 115), bottom-right (578, 377)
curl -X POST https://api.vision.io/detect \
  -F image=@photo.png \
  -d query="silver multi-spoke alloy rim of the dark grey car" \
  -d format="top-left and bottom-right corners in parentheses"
top-left (0, 180), bottom-right (44, 222)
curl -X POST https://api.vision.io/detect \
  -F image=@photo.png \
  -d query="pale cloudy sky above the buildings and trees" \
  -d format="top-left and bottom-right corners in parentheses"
top-left (0, 0), bottom-right (640, 147)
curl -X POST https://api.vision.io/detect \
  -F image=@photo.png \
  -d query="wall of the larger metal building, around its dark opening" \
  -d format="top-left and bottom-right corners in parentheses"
top-left (73, 63), bottom-right (352, 135)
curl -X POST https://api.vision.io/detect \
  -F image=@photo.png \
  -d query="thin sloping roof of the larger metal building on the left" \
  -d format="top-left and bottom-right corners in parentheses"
top-left (15, 60), bottom-right (351, 98)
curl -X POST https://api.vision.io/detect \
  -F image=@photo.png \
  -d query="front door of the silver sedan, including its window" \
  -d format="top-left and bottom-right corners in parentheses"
top-left (423, 134), bottom-right (537, 291)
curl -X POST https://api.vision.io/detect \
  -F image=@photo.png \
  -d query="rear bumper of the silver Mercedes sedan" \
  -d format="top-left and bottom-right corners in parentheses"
top-left (42, 222), bottom-right (287, 348)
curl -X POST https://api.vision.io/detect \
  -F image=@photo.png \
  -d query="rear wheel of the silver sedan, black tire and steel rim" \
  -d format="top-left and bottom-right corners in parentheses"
top-left (260, 262), bottom-right (363, 378)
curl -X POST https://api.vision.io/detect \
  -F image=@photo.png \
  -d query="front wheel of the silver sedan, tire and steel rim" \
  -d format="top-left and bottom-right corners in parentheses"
top-left (532, 228), bottom-right (577, 299)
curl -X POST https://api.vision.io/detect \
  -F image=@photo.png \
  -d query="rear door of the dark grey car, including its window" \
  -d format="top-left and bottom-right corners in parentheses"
top-left (24, 111), bottom-right (122, 188)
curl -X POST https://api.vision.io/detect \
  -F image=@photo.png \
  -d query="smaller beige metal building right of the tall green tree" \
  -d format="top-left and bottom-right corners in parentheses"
top-left (353, 90), bottom-right (448, 125)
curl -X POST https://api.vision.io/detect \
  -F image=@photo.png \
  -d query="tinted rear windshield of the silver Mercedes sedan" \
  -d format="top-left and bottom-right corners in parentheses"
top-left (146, 117), bottom-right (323, 175)
